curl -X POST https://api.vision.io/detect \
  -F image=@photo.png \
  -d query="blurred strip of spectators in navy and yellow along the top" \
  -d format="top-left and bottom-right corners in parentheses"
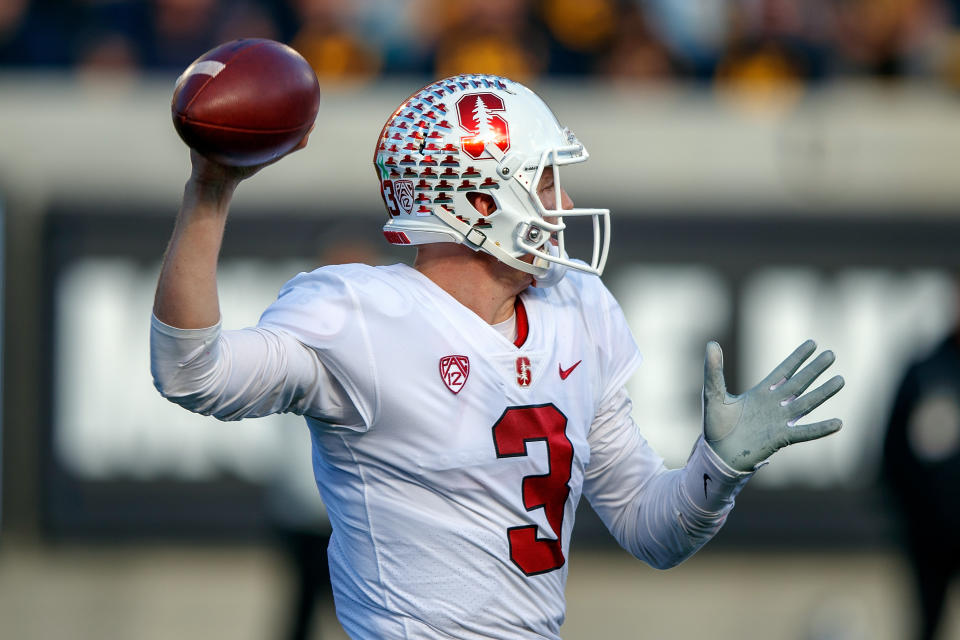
top-left (0, 0), bottom-right (960, 87)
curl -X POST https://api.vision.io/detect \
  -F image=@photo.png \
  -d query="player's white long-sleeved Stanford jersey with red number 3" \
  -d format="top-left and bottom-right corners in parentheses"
top-left (154, 265), bottom-right (747, 639)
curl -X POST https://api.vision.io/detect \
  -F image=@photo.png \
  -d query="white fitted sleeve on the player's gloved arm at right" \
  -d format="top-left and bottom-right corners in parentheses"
top-left (584, 388), bottom-right (752, 569)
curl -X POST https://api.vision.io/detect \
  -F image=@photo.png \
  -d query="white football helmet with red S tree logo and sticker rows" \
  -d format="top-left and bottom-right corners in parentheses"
top-left (373, 75), bottom-right (610, 286)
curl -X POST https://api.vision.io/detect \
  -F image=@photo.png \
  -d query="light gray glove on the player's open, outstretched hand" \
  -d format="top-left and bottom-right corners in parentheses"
top-left (703, 340), bottom-right (843, 471)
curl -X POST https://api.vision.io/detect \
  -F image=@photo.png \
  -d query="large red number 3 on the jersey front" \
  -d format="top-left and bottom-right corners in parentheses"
top-left (493, 404), bottom-right (573, 576)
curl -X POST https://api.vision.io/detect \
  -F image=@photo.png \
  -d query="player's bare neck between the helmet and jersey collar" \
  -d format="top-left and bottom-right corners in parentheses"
top-left (413, 243), bottom-right (532, 324)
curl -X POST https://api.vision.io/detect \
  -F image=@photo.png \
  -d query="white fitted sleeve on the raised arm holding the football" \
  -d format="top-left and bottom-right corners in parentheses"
top-left (150, 317), bottom-right (362, 428)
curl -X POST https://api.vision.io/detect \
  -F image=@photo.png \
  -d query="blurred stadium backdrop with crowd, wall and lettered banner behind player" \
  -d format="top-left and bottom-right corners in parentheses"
top-left (0, 0), bottom-right (960, 640)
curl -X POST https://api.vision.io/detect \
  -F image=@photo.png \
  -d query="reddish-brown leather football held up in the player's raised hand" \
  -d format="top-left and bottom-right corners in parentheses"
top-left (170, 38), bottom-right (320, 167)
